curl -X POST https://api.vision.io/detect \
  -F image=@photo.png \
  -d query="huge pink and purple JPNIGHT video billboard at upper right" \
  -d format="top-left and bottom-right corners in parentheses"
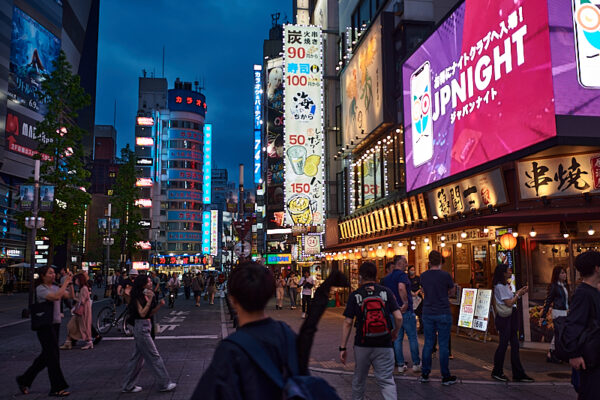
top-left (402, 0), bottom-right (600, 191)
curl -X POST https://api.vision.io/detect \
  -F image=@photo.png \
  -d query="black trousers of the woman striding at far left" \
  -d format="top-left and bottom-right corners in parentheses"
top-left (17, 324), bottom-right (69, 393)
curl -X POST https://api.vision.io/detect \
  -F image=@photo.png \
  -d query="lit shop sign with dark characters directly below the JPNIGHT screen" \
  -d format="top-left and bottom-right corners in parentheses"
top-left (428, 169), bottom-right (507, 218)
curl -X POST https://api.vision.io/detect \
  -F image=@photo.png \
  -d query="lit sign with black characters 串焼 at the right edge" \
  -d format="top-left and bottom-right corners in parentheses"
top-left (519, 153), bottom-right (600, 199)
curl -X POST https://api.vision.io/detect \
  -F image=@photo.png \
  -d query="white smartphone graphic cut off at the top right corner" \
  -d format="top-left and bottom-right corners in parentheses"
top-left (573, 0), bottom-right (600, 89)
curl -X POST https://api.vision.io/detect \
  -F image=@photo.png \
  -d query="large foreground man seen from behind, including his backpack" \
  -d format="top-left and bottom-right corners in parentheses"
top-left (191, 262), bottom-right (339, 400)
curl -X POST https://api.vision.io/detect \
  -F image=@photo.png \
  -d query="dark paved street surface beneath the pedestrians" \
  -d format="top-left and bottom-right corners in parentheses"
top-left (0, 293), bottom-right (575, 400)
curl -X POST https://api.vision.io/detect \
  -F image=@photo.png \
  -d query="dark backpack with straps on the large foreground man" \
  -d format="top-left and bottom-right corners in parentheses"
top-left (225, 324), bottom-right (341, 400)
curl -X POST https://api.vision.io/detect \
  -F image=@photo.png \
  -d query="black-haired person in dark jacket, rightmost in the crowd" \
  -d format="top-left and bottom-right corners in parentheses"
top-left (561, 251), bottom-right (600, 400)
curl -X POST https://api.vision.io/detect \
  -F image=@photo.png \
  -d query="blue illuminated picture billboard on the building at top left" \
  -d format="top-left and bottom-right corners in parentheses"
top-left (8, 7), bottom-right (60, 114)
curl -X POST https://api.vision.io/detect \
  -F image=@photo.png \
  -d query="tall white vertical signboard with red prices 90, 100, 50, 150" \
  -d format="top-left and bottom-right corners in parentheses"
top-left (283, 25), bottom-right (325, 226)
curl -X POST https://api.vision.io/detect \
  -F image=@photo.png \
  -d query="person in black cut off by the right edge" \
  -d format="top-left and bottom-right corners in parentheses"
top-left (559, 251), bottom-right (600, 400)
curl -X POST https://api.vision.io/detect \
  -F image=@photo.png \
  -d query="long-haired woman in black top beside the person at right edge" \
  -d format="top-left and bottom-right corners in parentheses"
top-left (540, 266), bottom-right (569, 364)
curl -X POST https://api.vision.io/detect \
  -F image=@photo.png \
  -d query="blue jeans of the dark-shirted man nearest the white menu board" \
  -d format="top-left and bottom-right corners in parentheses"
top-left (422, 314), bottom-right (452, 377)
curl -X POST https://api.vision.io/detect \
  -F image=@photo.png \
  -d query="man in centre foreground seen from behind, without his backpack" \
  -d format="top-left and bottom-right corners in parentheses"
top-left (192, 263), bottom-right (287, 400)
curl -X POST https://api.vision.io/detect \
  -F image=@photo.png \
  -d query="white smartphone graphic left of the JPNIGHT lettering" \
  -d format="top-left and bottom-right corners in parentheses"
top-left (410, 61), bottom-right (433, 167)
